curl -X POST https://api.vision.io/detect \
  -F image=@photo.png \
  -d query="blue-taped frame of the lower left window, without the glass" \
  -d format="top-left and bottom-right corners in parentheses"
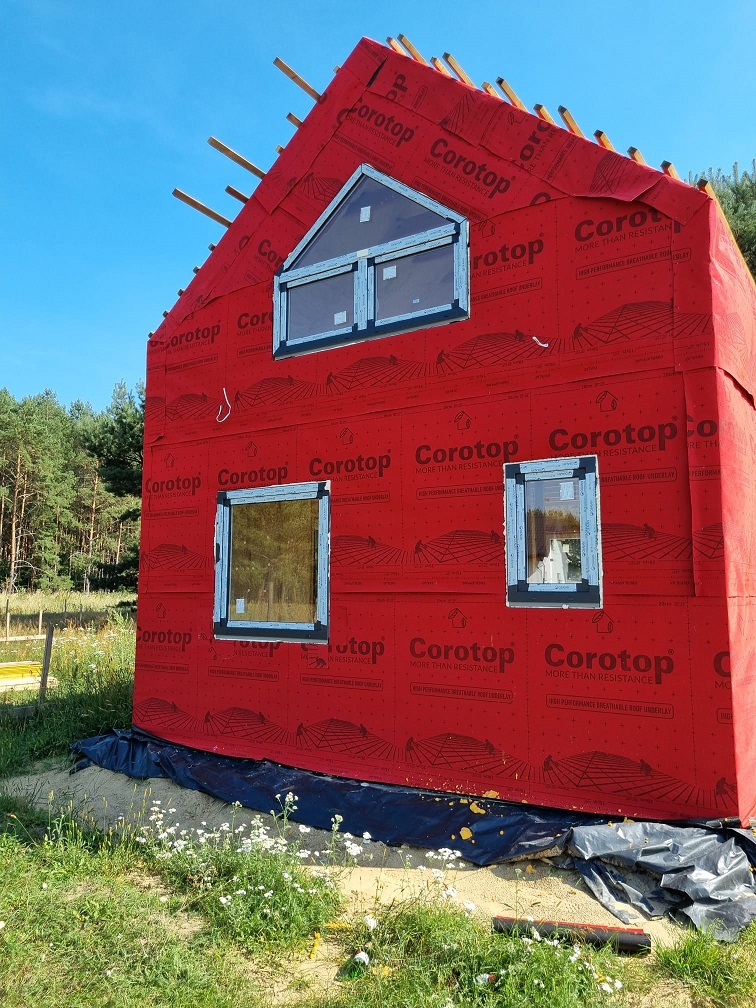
top-left (213, 480), bottom-right (331, 644)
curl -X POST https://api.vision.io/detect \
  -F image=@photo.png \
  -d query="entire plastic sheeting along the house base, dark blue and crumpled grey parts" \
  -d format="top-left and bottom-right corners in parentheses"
top-left (71, 729), bottom-right (756, 940)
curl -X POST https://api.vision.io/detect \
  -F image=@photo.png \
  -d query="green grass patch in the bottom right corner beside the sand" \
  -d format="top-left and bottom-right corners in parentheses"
top-left (656, 924), bottom-right (756, 1008)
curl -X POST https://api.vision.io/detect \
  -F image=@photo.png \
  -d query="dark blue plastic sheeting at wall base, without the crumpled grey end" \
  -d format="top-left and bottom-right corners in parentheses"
top-left (72, 731), bottom-right (608, 865)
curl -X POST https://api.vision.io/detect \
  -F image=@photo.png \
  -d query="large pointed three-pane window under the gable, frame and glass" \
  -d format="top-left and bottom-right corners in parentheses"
top-left (273, 164), bottom-right (470, 357)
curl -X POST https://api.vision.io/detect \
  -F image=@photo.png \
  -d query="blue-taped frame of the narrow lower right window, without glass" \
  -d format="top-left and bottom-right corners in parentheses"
top-left (504, 455), bottom-right (604, 609)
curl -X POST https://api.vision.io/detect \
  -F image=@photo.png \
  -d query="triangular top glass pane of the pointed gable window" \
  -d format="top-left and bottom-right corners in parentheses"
top-left (289, 175), bottom-right (450, 269)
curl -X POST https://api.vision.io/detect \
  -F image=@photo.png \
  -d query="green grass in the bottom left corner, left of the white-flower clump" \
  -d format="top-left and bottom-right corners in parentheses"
top-left (0, 805), bottom-right (270, 1008)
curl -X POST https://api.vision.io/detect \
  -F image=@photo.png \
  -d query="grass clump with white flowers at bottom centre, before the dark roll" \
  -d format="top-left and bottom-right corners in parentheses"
top-left (298, 894), bottom-right (625, 1008)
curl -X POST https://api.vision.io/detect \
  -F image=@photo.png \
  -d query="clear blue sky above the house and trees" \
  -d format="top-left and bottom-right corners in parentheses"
top-left (0, 0), bottom-right (756, 409)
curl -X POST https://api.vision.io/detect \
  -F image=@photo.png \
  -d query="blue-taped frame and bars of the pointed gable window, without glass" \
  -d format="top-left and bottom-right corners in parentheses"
top-left (273, 164), bottom-right (470, 359)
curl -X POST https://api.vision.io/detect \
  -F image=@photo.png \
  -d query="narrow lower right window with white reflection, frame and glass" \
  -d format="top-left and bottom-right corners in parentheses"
top-left (504, 455), bottom-right (602, 609)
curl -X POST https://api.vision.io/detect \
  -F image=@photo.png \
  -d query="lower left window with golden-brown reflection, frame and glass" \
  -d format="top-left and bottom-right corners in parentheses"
top-left (215, 483), bottom-right (331, 642)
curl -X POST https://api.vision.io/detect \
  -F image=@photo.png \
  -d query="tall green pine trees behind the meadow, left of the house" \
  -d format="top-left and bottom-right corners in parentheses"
top-left (0, 384), bottom-right (143, 595)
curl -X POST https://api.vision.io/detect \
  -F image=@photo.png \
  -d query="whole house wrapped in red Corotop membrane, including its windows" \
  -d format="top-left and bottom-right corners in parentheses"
top-left (134, 39), bottom-right (756, 823)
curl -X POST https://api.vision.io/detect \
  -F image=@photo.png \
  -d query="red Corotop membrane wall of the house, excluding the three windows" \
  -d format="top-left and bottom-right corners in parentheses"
top-left (135, 40), bottom-right (756, 817)
